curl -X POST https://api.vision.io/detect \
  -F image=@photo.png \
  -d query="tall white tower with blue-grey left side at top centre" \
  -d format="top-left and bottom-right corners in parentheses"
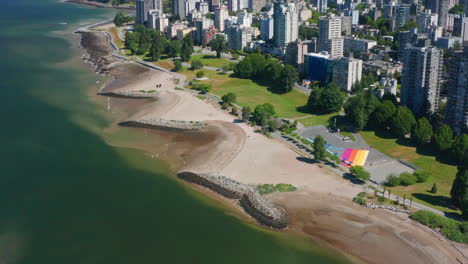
top-left (273, 2), bottom-right (299, 47)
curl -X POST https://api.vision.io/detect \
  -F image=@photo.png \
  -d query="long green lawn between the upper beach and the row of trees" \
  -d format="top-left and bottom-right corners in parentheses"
top-left (184, 70), bottom-right (307, 118)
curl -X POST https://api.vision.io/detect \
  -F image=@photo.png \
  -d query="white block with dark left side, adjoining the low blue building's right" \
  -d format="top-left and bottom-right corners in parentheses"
top-left (332, 57), bottom-right (362, 92)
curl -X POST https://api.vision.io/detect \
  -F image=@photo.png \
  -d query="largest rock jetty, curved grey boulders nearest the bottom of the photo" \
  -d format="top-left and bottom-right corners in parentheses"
top-left (177, 172), bottom-right (288, 229)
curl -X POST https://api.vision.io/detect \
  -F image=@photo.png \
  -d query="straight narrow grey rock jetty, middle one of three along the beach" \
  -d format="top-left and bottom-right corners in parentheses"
top-left (119, 118), bottom-right (208, 131)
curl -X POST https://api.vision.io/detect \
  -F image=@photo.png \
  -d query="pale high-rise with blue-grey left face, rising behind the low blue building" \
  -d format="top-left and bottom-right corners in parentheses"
top-left (318, 14), bottom-right (343, 57)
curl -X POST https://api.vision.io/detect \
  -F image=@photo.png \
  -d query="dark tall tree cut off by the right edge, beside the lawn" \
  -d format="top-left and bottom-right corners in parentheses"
top-left (450, 151), bottom-right (468, 219)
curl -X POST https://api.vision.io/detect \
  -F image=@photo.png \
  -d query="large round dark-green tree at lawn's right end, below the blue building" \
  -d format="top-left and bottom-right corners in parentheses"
top-left (307, 82), bottom-right (345, 114)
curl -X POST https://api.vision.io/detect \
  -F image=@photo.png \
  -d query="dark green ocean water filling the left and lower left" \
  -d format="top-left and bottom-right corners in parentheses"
top-left (0, 0), bottom-right (348, 264)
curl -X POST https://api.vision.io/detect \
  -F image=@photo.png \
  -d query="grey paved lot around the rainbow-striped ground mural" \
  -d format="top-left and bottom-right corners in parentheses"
top-left (297, 125), bottom-right (414, 184)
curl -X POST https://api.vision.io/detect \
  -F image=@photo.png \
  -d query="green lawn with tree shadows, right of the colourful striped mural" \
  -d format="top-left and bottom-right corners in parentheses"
top-left (360, 131), bottom-right (458, 213)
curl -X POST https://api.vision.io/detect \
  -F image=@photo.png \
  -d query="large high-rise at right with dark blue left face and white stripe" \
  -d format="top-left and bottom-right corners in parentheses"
top-left (401, 46), bottom-right (443, 115)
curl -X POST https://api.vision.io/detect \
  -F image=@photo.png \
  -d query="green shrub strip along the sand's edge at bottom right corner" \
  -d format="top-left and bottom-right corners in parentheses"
top-left (410, 210), bottom-right (468, 243)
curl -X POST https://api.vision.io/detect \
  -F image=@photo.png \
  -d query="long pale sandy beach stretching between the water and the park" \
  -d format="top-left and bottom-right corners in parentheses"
top-left (82, 29), bottom-right (468, 263)
